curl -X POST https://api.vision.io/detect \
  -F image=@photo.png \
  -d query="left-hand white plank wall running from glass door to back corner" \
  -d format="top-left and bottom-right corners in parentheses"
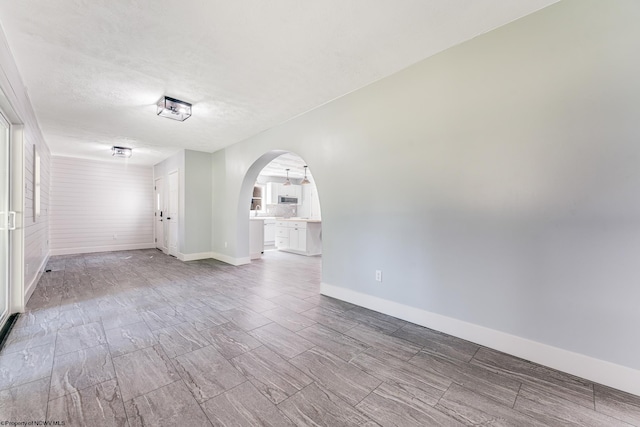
top-left (0, 23), bottom-right (51, 310)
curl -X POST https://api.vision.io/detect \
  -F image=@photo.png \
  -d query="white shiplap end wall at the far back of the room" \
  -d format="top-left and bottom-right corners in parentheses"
top-left (50, 158), bottom-right (155, 255)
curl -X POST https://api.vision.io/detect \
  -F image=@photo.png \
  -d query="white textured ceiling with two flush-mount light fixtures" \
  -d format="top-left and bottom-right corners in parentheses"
top-left (0, 0), bottom-right (556, 164)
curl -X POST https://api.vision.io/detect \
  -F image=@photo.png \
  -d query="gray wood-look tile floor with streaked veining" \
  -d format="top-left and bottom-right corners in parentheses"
top-left (0, 250), bottom-right (640, 427)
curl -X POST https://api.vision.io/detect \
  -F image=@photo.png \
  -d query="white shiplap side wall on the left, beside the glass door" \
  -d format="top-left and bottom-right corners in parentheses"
top-left (0, 26), bottom-right (51, 306)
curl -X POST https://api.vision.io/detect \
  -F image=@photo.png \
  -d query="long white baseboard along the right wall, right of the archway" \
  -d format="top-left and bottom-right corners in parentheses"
top-left (320, 283), bottom-right (640, 396)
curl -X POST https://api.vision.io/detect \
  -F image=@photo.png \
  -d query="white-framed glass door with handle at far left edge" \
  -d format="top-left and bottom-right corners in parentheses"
top-left (0, 113), bottom-right (10, 327)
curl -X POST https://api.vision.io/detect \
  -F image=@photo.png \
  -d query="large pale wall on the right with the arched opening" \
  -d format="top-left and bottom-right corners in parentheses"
top-left (213, 0), bottom-right (640, 394)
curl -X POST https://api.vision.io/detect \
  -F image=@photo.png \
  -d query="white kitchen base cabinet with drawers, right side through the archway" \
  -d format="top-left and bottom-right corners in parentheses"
top-left (276, 220), bottom-right (322, 256)
